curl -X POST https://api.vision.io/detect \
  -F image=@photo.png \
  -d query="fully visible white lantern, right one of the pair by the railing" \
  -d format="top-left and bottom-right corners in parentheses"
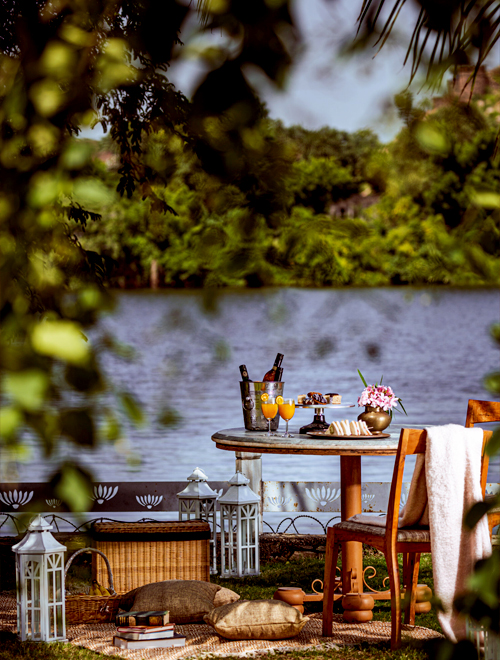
top-left (219, 472), bottom-right (260, 577)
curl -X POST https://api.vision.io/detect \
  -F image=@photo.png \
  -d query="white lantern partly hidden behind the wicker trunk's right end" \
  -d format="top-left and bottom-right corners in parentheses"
top-left (177, 468), bottom-right (218, 575)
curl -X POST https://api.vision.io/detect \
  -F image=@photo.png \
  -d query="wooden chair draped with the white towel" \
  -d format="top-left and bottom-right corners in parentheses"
top-left (323, 429), bottom-right (491, 649)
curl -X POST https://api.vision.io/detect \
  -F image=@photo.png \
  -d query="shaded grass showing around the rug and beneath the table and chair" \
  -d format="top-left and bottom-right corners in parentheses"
top-left (0, 551), bottom-right (441, 660)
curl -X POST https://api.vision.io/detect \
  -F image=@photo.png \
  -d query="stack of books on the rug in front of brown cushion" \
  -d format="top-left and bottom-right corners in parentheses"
top-left (113, 611), bottom-right (186, 649)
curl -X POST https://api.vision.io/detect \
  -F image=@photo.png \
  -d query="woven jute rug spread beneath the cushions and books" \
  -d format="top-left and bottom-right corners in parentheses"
top-left (0, 595), bottom-right (442, 660)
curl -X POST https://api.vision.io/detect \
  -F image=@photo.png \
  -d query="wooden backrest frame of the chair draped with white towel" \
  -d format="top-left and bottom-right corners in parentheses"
top-left (386, 428), bottom-right (492, 536)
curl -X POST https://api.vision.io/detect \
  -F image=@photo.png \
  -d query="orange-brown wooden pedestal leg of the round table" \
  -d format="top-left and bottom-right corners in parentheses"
top-left (340, 456), bottom-right (374, 623)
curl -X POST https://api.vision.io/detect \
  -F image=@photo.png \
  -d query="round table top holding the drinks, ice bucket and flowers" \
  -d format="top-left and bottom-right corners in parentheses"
top-left (212, 428), bottom-right (399, 456)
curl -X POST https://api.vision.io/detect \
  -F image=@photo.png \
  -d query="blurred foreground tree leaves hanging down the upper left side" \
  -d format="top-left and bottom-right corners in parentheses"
top-left (0, 0), bottom-right (297, 507)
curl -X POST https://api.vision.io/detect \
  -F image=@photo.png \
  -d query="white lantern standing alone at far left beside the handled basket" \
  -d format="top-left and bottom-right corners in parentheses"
top-left (12, 515), bottom-right (66, 642)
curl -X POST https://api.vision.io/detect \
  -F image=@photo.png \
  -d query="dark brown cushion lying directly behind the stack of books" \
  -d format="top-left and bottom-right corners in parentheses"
top-left (132, 580), bottom-right (221, 623)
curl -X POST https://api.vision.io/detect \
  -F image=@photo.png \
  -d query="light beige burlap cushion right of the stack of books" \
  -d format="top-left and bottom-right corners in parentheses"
top-left (203, 600), bottom-right (308, 639)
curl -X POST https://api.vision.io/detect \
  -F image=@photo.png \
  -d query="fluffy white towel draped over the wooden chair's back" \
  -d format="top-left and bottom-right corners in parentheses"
top-left (350, 424), bottom-right (491, 642)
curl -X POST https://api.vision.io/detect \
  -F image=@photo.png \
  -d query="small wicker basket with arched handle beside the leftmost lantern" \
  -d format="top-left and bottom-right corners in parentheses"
top-left (64, 548), bottom-right (131, 623)
